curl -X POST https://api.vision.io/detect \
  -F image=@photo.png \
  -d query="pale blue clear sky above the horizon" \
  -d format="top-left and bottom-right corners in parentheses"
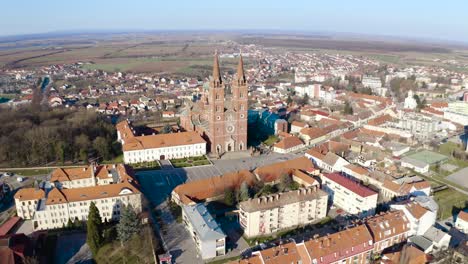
top-left (0, 0), bottom-right (468, 42)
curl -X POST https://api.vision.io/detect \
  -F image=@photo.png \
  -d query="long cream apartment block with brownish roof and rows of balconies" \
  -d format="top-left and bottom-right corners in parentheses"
top-left (239, 186), bottom-right (328, 237)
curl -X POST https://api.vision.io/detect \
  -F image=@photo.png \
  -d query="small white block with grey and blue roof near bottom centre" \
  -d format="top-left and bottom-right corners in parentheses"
top-left (182, 203), bottom-right (226, 259)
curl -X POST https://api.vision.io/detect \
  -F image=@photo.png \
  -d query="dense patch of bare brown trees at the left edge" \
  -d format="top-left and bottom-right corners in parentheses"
top-left (0, 106), bottom-right (120, 167)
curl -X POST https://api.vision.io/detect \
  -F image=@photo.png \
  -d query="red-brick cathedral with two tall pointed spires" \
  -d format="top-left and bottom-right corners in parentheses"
top-left (180, 53), bottom-right (248, 155)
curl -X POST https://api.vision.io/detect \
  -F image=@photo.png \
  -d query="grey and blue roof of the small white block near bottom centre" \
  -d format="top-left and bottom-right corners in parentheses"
top-left (182, 203), bottom-right (226, 241)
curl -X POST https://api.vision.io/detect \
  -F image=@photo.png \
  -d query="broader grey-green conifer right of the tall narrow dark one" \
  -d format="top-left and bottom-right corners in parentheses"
top-left (117, 205), bottom-right (140, 246)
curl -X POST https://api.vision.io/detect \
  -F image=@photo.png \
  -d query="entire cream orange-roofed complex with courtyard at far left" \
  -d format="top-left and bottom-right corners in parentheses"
top-left (15, 164), bottom-right (142, 230)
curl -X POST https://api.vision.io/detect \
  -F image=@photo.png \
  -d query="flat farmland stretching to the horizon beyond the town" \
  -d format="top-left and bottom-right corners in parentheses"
top-left (0, 33), bottom-right (468, 75)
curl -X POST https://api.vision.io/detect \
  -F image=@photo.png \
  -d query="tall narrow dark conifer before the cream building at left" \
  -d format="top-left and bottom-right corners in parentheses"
top-left (86, 202), bottom-right (103, 256)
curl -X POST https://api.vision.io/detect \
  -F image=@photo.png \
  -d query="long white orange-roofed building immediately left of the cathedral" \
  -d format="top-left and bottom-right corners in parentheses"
top-left (117, 121), bottom-right (206, 163)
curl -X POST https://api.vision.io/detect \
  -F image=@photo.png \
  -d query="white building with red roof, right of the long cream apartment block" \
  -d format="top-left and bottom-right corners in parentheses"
top-left (321, 173), bottom-right (378, 217)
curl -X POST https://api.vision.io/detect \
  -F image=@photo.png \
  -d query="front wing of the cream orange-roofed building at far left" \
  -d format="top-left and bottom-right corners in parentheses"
top-left (15, 165), bottom-right (142, 230)
